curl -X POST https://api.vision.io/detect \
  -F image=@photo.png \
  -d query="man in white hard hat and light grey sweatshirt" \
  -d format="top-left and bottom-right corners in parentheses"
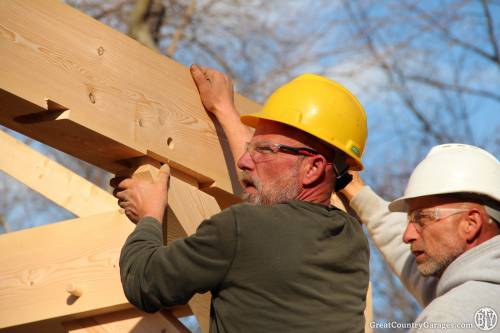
top-left (342, 144), bottom-right (500, 332)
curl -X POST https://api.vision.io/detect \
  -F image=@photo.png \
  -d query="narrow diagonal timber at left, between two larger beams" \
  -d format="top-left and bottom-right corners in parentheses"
top-left (0, 130), bottom-right (119, 217)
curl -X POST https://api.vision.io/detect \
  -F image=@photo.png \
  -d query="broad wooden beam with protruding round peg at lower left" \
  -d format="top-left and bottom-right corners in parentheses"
top-left (0, 212), bottom-right (188, 328)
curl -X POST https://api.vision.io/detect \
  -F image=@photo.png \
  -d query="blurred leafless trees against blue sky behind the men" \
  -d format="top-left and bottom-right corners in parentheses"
top-left (0, 0), bottom-right (500, 321)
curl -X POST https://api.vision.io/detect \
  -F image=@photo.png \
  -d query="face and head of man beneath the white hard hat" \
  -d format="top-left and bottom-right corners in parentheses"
top-left (403, 194), bottom-right (500, 276)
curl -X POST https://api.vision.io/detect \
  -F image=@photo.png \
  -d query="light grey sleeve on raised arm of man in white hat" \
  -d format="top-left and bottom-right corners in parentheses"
top-left (350, 186), bottom-right (438, 306)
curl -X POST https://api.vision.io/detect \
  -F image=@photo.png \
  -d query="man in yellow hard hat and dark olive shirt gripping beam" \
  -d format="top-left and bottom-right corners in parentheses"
top-left (115, 66), bottom-right (369, 333)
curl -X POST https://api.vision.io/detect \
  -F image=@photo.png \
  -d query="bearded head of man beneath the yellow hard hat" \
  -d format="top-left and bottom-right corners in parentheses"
top-left (238, 120), bottom-right (342, 205)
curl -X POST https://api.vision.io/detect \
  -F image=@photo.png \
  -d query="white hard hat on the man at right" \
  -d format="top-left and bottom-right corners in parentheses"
top-left (389, 143), bottom-right (500, 215)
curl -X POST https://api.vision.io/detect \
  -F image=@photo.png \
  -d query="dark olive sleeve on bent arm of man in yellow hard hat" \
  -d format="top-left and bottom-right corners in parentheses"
top-left (120, 210), bottom-right (236, 312)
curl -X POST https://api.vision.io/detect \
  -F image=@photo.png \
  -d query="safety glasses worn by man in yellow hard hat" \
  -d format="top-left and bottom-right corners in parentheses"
top-left (245, 142), bottom-right (320, 162)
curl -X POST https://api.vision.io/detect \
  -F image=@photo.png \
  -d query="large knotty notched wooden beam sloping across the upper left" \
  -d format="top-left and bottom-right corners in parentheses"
top-left (0, 0), bottom-right (259, 197)
